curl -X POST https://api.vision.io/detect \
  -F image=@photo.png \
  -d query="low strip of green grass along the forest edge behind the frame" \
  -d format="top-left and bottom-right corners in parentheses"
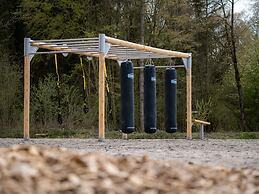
top-left (0, 129), bottom-right (259, 139)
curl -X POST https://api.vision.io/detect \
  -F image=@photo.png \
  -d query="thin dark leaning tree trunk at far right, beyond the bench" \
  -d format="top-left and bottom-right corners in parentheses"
top-left (233, 0), bottom-right (245, 130)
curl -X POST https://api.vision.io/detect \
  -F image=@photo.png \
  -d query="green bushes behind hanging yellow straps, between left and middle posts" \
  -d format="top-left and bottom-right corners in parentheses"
top-left (31, 68), bottom-right (101, 129)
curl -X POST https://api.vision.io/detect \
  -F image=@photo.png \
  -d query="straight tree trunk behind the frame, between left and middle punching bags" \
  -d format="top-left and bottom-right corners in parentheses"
top-left (139, 0), bottom-right (145, 131)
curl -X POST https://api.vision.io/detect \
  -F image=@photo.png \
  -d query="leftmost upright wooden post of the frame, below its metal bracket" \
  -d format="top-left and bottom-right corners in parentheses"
top-left (23, 55), bottom-right (30, 139)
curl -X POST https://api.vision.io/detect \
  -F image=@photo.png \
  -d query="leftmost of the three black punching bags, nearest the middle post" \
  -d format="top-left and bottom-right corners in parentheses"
top-left (120, 61), bottom-right (134, 133)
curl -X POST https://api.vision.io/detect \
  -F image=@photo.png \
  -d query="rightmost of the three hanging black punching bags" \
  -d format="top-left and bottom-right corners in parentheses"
top-left (165, 68), bottom-right (177, 133)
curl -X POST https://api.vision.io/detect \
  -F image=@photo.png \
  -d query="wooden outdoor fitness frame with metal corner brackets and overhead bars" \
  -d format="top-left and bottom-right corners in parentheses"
top-left (24, 34), bottom-right (193, 140)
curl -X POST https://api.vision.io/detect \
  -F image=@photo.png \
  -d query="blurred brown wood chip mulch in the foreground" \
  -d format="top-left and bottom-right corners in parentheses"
top-left (0, 146), bottom-right (259, 194)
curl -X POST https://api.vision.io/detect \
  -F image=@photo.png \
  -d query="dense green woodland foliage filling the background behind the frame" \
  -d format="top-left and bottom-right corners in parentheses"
top-left (0, 0), bottom-right (259, 135)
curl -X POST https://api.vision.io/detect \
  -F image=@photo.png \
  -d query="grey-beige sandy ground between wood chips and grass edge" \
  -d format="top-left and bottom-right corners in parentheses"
top-left (0, 139), bottom-right (259, 168)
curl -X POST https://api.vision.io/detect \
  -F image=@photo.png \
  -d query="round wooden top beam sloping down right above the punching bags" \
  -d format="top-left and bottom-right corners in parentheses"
top-left (106, 36), bottom-right (191, 58)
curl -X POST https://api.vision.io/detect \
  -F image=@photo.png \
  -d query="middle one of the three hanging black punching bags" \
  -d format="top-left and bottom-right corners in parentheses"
top-left (144, 65), bottom-right (156, 133)
